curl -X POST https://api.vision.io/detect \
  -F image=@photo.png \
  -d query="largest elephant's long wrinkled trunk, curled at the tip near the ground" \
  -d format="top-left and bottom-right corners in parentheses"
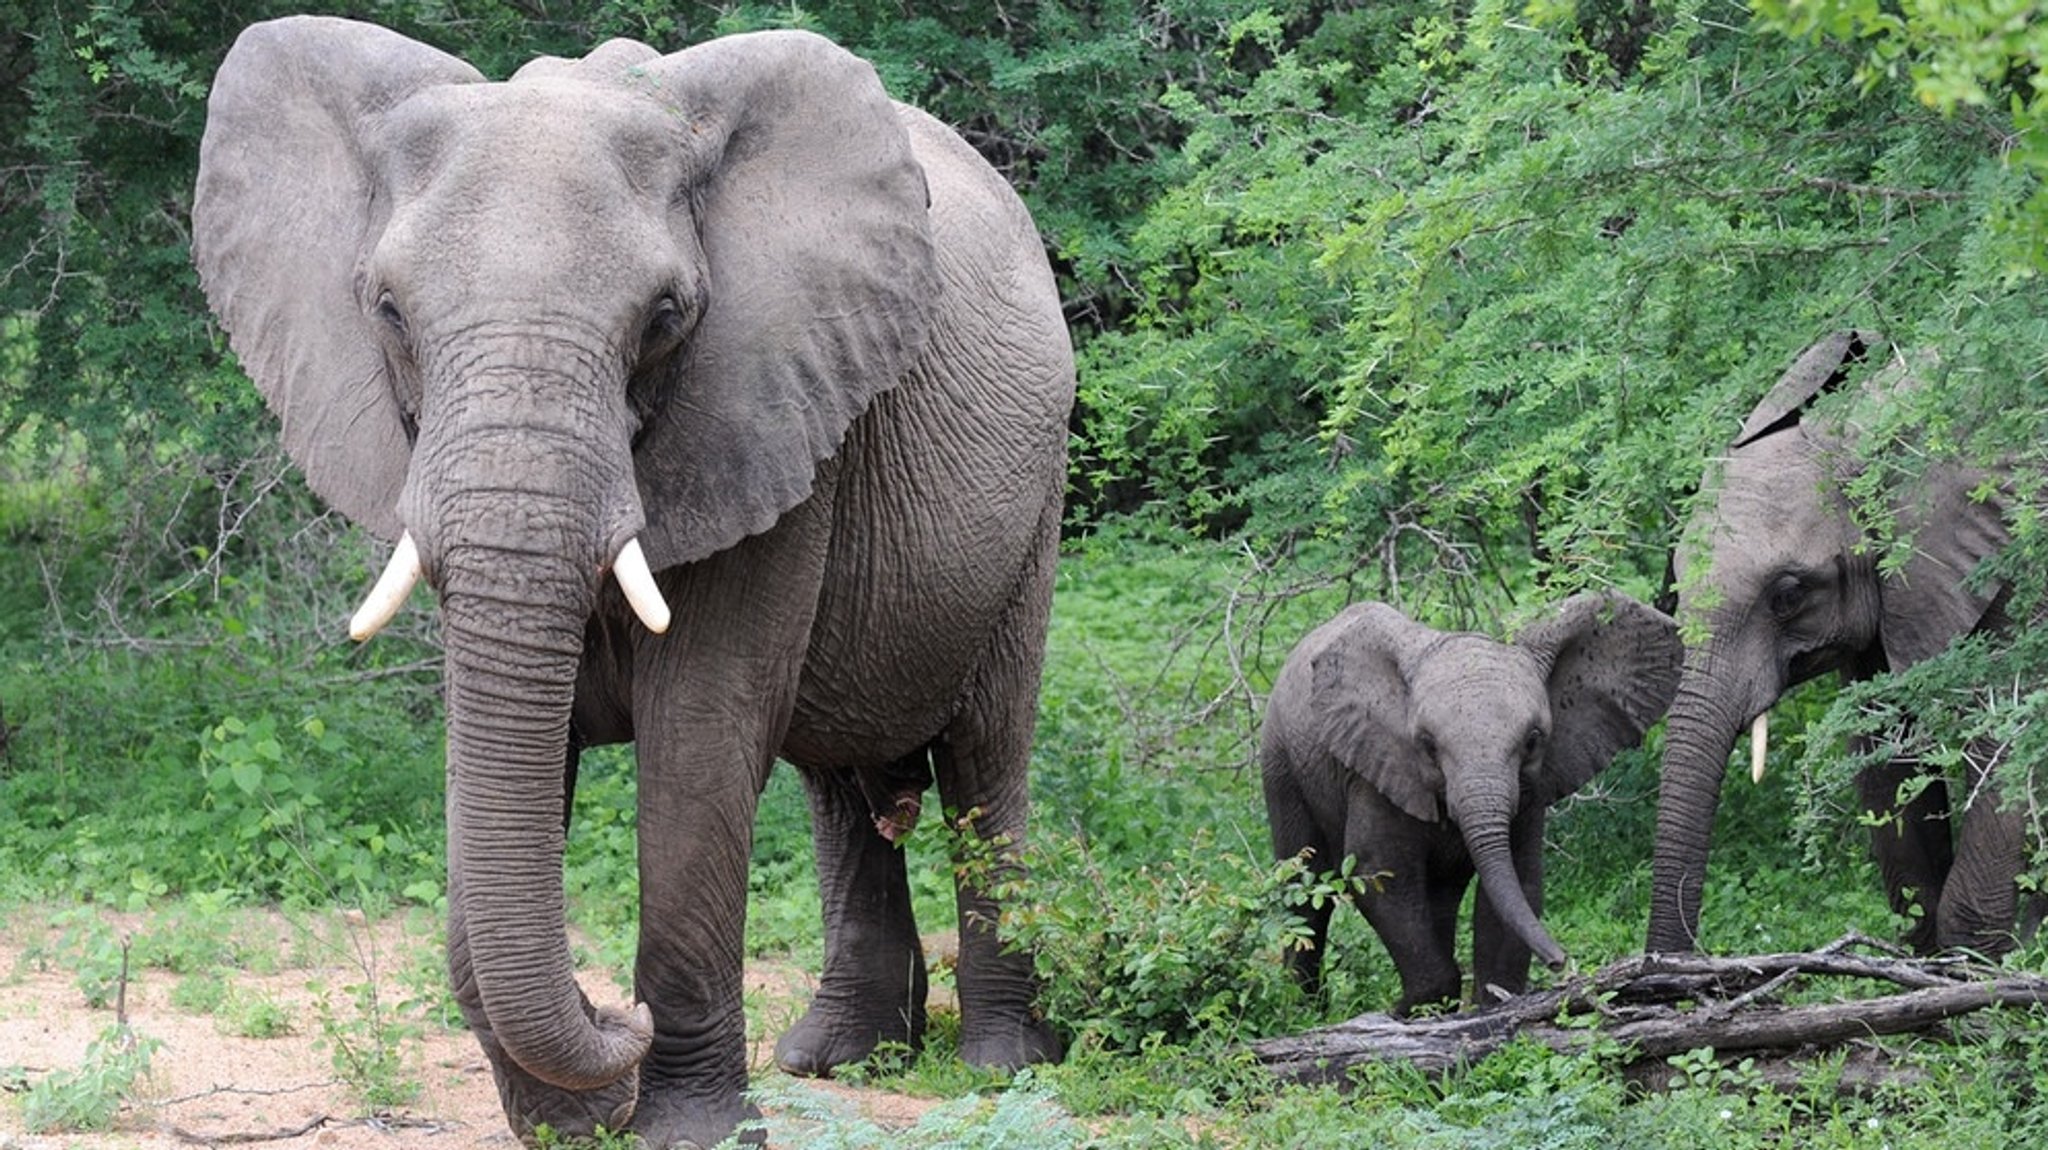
top-left (401, 356), bottom-right (666, 1091)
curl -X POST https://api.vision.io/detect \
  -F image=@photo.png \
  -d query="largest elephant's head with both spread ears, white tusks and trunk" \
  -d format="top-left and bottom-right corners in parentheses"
top-left (193, 16), bottom-right (936, 1091)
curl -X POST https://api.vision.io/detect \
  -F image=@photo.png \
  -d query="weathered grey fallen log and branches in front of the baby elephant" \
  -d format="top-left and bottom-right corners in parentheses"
top-left (1251, 933), bottom-right (2048, 1082)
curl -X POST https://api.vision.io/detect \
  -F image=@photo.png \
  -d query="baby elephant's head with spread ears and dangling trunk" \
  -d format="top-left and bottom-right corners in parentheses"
top-left (1310, 593), bottom-right (1679, 966)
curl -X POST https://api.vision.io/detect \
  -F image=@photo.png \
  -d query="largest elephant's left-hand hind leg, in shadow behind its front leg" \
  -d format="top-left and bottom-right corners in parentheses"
top-left (774, 749), bottom-right (930, 1076)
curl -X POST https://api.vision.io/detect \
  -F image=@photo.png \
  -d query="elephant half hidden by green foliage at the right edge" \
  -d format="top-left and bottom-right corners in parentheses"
top-left (1647, 331), bottom-right (2025, 954)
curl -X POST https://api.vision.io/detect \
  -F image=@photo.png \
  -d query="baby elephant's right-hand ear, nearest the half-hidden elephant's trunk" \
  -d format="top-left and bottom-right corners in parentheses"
top-left (1516, 591), bottom-right (1686, 806)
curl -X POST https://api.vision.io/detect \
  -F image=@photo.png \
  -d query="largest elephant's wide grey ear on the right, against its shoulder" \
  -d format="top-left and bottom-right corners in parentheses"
top-left (602, 31), bottom-right (942, 567)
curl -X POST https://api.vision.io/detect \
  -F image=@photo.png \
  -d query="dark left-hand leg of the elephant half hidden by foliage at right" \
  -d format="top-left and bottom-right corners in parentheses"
top-left (1849, 739), bottom-right (1949, 954)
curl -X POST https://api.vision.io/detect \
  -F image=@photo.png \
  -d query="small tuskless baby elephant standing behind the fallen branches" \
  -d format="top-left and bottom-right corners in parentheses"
top-left (1260, 593), bottom-right (1683, 1015)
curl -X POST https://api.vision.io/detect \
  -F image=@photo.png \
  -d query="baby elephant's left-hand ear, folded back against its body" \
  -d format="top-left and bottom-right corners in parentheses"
top-left (1309, 604), bottom-right (1444, 823)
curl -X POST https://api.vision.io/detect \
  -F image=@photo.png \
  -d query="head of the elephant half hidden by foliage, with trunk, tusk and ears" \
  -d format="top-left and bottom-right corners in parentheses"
top-left (1647, 331), bottom-right (2007, 952)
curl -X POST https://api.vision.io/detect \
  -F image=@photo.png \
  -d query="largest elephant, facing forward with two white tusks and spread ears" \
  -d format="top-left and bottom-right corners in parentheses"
top-left (193, 16), bottom-right (1073, 1146)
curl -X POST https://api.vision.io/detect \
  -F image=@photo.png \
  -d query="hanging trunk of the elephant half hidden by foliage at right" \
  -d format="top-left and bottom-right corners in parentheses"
top-left (1645, 661), bottom-right (1751, 954)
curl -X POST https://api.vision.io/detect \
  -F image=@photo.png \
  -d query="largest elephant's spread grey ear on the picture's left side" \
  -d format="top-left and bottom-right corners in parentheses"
top-left (193, 16), bottom-right (481, 538)
